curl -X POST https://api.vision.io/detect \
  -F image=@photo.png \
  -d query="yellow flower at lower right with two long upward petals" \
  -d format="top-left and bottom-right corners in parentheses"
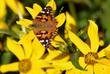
top-left (67, 20), bottom-right (110, 74)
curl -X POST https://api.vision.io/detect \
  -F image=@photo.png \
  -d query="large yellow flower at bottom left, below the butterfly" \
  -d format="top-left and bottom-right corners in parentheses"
top-left (0, 31), bottom-right (50, 74)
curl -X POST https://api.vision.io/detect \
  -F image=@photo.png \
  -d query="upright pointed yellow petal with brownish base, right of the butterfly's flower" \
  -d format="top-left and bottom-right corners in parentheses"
top-left (65, 12), bottom-right (76, 30)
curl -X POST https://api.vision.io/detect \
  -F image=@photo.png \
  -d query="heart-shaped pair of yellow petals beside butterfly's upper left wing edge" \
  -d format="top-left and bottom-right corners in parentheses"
top-left (26, 4), bottom-right (42, 19)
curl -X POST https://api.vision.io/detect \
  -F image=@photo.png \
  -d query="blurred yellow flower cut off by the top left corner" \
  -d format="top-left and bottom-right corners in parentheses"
top-left (0, 0), bottom-right (25, 19)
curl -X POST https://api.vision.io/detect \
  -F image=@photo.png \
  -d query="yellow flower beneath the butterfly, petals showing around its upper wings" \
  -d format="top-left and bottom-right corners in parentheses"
top-left (17, 0), bottom-right (65, 27)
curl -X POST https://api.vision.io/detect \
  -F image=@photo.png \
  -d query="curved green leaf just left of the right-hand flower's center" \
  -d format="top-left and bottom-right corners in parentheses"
top-left (71, 51), bottom-right (86, 71)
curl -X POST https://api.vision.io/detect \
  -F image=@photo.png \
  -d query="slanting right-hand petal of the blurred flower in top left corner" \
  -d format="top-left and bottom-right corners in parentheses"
top-left (5, 0), bottom-right (25, 14)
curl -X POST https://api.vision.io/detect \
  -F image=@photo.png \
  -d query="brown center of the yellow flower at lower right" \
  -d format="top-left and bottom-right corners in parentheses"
top-left (85, 52), bottom-right (98, 65)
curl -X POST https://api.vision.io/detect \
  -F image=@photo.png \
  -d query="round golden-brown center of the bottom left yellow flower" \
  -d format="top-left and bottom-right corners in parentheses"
top-left (18, 59), bottom-right (32, 73)
